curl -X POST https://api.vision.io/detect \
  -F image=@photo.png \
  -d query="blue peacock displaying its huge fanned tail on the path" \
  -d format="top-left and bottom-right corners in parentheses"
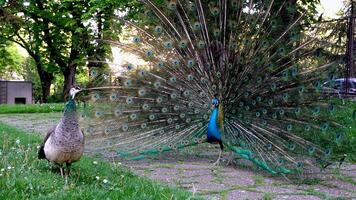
top-left (80, 0), bottom-right (344, 175)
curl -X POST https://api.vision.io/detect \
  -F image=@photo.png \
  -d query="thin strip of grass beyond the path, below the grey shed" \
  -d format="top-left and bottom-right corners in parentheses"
top-left (0, 103), bottom-right (64, 114)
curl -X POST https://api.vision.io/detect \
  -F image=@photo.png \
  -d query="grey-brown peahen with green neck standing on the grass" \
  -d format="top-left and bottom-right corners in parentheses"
top-left (38, 87), bottom-right (84, 180)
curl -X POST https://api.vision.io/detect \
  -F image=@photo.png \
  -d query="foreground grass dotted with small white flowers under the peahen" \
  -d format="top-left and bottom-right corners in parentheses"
top-left (0, 123), bottom-right (200, 200)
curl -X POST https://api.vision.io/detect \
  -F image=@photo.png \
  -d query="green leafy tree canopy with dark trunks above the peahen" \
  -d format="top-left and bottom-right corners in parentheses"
top-left (0, 0), bottom-right (136, 101)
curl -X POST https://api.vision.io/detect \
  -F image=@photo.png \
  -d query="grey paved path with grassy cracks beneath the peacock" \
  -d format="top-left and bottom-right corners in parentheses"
top-left (0, 113), bottom-right (356, 200)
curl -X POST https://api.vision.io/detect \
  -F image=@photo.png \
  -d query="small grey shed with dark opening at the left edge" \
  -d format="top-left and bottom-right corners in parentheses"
top-left (0, 80), bottom-right (32, 104)
